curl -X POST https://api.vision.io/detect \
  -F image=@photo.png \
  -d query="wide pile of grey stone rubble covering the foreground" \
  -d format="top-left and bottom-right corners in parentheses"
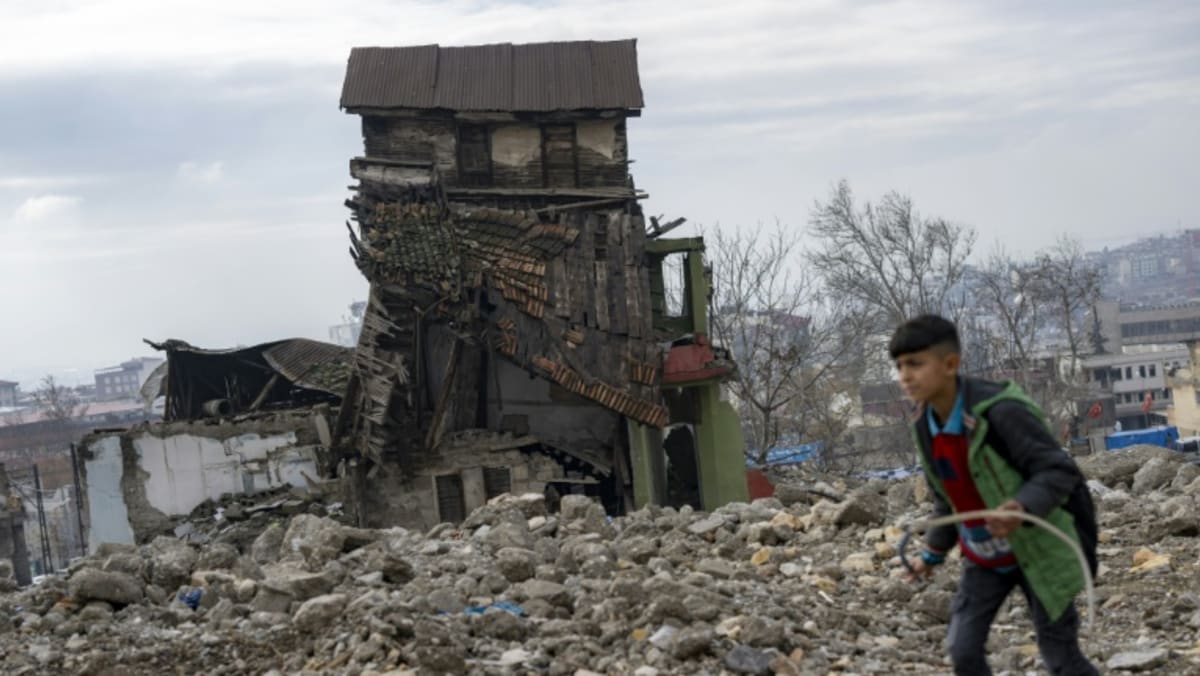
top-left (0, 448), bottom-right (1200, 676)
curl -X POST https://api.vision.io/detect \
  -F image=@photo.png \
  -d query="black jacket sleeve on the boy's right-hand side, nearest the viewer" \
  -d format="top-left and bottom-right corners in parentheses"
top-left (988, 401), bottom-right (1082, 516)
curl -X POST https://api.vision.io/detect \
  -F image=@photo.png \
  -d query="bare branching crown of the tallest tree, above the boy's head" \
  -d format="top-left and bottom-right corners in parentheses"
top-left (810, 180), bottom-right (976, 328)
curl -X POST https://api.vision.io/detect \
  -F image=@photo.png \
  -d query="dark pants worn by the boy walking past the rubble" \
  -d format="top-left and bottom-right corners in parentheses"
top-left (946, 563), bottom-right (1099, 676)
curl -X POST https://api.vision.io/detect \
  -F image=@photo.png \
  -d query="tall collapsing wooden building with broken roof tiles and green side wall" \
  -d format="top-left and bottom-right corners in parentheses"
top-left (335, 40), bottom-right (746, 527)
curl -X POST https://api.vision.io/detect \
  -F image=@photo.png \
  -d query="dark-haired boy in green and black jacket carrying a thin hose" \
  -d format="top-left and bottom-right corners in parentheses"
top-left (889, 315), bottom-right (1098, 675)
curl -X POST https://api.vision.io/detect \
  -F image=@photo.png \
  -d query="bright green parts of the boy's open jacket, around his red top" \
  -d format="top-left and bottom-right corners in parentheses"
top-left (913, 382), bottom-right (1085, 622)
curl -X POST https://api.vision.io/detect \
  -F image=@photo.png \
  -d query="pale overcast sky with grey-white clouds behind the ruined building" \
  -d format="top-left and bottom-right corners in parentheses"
top-left (0, 0), bottom-right (1200, 387)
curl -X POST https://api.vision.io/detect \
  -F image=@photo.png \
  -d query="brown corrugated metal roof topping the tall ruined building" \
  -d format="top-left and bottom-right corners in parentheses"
top-left (341, 40), bottom-right (643, 112)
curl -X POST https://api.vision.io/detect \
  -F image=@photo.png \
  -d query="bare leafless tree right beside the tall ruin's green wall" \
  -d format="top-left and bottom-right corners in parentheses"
top-left (708, 226), bottom-right (860, 461)
